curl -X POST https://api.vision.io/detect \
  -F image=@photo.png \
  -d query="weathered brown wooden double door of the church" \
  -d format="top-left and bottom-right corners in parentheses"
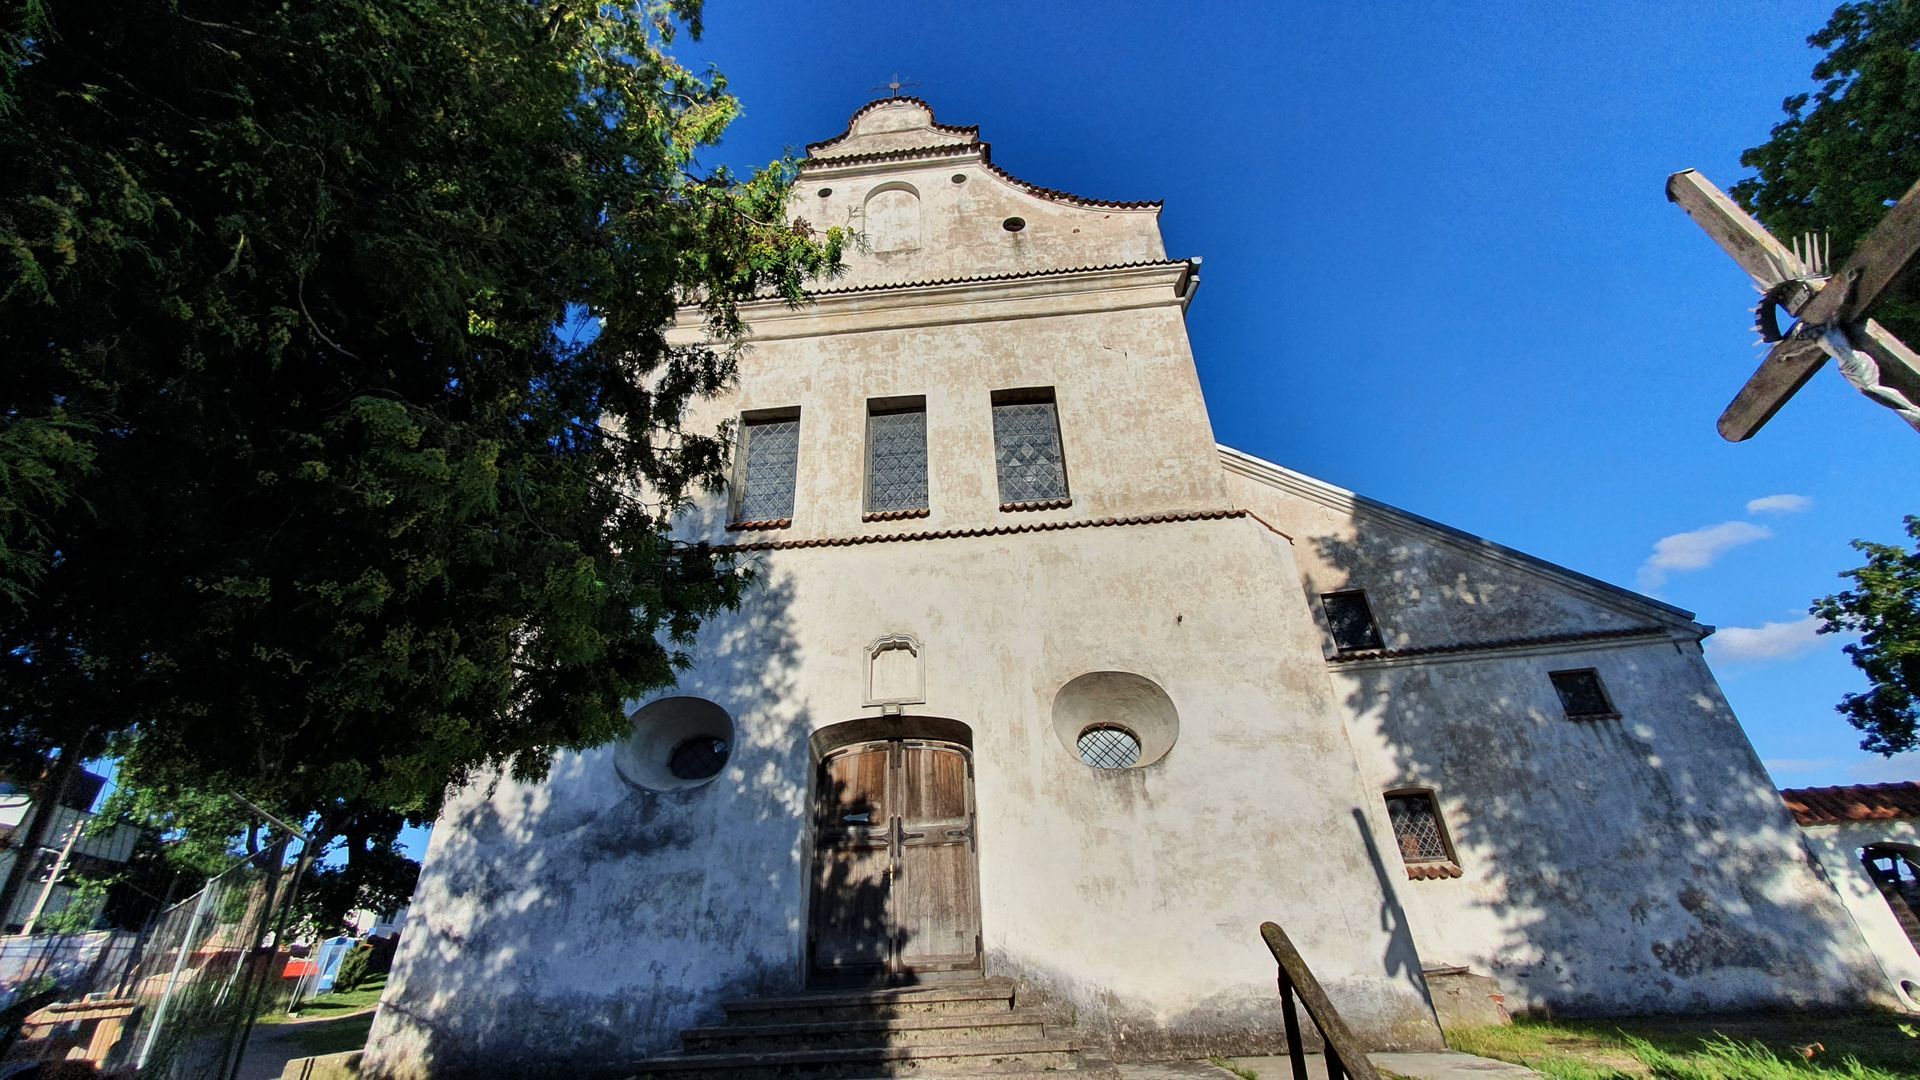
top-left (810, 738), bottom-right (981, 984)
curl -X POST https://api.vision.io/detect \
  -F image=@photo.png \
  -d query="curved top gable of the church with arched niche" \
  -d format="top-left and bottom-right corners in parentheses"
top-left (791, 98), bottom-right (1165, 294)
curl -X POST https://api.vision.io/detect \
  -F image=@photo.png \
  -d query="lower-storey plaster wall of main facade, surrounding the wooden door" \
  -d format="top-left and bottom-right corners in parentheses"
top-left (362, 519), bottom-right (1438, 1074)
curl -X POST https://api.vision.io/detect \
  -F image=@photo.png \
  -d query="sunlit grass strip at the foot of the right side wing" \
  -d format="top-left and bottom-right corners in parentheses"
top-left (1446, 1013), bottom-right (1920, 1080)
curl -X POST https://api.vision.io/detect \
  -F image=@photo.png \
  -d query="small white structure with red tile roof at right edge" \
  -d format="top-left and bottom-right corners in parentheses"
top-left (1780, 780), bottom-right (1920, 1011)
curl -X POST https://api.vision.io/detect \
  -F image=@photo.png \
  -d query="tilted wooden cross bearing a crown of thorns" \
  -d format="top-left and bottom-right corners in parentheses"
top-left (1667, 169), bottom-right (1920, 442)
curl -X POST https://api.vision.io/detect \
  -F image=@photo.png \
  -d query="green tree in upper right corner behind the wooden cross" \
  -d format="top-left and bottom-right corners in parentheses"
top-left (1732, 0), bottom-right (1920, 344)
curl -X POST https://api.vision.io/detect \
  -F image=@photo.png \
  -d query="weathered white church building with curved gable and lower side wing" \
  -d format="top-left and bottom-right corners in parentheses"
top-left (367, 98), bottom-right (1897, 1076)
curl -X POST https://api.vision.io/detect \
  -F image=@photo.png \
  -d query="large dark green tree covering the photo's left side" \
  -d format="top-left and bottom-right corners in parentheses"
top-left (0, 0), bottom-right (845, 876)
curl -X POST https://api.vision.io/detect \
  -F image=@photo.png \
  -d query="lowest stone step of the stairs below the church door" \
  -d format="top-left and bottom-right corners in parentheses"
top-left (632, 1040), bottom-right (1079, 1080)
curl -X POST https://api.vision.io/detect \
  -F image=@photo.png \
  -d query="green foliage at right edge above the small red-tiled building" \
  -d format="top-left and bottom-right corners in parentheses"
top-left (1811, 515), bottom-right (1920, 755)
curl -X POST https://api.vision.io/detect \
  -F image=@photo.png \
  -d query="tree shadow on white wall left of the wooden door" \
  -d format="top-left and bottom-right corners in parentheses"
top-left (367, 567), bottom-right (840, 1078)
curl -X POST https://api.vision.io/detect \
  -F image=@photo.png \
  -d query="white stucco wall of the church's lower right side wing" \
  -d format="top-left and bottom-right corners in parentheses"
top-left (1225, 452), bottom-right (1887, 1013)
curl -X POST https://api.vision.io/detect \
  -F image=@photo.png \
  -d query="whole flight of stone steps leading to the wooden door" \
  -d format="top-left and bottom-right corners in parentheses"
top-left (634, 978), bottom-right (1119, 1080)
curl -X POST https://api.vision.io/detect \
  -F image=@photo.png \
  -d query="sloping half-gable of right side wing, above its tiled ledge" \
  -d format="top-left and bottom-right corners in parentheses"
top-left (1221, 440), bottom-right (1709, 657)
